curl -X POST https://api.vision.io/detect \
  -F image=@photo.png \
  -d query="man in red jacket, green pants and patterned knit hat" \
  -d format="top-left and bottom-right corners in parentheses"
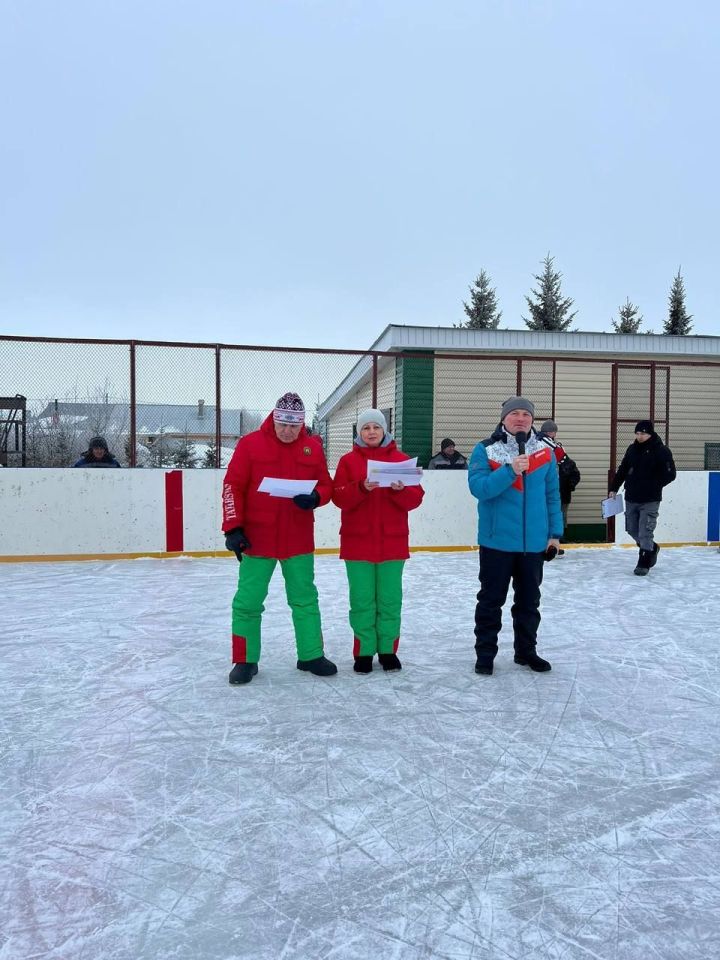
top-left (222, 393), bottom-right (337, 684)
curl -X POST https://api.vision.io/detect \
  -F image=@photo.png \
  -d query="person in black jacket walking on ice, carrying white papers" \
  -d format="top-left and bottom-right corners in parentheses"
top-left (609, 420), bottom-right (676, 577)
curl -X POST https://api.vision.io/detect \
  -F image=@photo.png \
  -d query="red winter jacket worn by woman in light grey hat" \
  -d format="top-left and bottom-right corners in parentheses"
top-left (332, 440), bottom-right (425, 563)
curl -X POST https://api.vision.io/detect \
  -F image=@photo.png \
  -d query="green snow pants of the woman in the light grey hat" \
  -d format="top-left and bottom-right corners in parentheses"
top-left (345, 560), bottom-right (405, 657)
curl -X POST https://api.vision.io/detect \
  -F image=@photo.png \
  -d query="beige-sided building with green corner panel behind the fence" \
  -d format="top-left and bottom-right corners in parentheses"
top-left (317, 325), bottom-right (720, 541)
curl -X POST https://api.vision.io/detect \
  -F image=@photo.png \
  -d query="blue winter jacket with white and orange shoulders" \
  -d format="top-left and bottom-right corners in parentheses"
top-left (468, 427), bottom-right (563, 553)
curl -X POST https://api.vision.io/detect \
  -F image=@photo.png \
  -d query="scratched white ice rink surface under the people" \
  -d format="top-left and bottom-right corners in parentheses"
top-left (0, 547), bottom-right (720, 960)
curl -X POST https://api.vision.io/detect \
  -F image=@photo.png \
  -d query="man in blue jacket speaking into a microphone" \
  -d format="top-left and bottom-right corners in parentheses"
top-left (468, 397), bottom-right (563, 674)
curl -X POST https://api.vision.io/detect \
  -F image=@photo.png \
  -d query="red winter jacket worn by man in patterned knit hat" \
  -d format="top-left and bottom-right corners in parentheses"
top-left (222, 414), bottom-right (332, 560)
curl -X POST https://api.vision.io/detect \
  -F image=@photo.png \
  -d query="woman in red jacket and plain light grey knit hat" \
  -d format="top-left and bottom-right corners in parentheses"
top-left (332, 410), bottom-right (424, 673)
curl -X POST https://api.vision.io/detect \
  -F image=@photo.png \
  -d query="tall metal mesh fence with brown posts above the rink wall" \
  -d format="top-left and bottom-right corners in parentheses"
top-left (0, 336), bottom-right (720, 483)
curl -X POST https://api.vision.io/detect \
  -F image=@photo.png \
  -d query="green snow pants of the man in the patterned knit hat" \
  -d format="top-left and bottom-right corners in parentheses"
top-left (232, 553), bottom-right (323, 663)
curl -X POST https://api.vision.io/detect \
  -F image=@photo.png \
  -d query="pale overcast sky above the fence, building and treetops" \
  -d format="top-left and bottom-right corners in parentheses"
top-left (0, 0), bottom-right (720, 348)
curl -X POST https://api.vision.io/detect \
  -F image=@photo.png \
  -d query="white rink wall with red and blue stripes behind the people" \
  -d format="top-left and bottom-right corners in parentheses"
top-left (0, 468), bottom-right (717, 560)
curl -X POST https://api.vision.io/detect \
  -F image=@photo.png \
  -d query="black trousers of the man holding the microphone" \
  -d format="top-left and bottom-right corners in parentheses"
top-left (475, 547), bottom-right (545, 663)
